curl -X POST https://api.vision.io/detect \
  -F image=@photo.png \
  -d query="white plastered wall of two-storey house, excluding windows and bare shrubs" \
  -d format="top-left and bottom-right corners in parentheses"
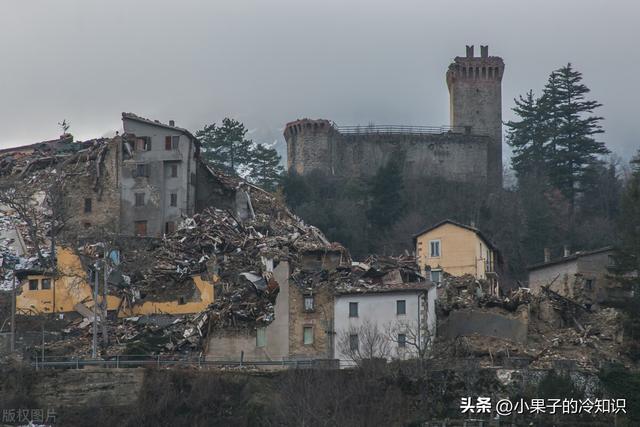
top-left (333, 286), bottom-right (436, 366)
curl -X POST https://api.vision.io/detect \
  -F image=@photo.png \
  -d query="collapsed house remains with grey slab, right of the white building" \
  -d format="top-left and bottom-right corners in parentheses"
top-left (433, 275), bottom-right (632, 371)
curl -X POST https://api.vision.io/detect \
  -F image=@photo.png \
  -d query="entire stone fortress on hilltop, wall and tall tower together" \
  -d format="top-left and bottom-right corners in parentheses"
top-left (284, 46), bottom-right (504, 188)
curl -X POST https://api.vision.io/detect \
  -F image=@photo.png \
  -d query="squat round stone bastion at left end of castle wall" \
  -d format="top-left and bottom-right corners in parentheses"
top-left (284, 119), bottom-right (335, 175)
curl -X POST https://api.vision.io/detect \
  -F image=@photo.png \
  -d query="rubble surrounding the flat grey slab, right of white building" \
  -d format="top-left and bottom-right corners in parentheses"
top-left (434, 275), bottom-right (630, 371)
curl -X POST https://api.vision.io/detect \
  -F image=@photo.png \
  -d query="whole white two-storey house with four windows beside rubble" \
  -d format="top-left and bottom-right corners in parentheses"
top-left (334, 282), bottom-right (436, 366)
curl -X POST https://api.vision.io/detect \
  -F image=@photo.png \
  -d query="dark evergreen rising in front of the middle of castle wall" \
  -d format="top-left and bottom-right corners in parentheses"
top-left (367, 158), bottom-right (404, 230)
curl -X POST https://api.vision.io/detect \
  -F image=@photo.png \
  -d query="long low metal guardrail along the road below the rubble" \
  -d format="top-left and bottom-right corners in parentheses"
top-left (31, 355), bottom-right (340, 369)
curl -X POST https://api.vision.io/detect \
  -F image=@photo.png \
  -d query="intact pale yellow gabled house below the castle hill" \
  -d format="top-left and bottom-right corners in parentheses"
top-left (413, 219), bottom-right (500, 292)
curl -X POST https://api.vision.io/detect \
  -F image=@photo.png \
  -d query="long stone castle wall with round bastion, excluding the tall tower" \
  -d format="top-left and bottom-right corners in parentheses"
top-left (285, 120), bottom-right (490, 183)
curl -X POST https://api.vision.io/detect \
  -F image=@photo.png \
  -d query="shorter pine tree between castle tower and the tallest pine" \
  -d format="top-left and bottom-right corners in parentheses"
top-left (506, 90), bottom-right (547, 179)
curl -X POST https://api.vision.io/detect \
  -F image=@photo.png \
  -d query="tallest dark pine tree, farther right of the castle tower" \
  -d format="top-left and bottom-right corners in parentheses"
top-left (540, 64), bottom-right (609, 214)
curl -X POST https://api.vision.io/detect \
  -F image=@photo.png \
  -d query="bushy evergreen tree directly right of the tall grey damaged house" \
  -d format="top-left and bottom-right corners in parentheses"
top-left (196, 118), bottom-right (252, 176)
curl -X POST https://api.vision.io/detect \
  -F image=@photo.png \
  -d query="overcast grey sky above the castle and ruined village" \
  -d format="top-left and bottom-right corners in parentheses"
top-left (0, 0), bottom-right (640, 162)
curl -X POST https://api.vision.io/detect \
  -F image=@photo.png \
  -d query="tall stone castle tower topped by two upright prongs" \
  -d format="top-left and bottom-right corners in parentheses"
top-left (447, 46), bottom-right (504, 188)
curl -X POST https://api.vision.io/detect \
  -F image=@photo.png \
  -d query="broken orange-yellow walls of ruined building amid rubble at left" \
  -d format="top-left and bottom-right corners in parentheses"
top-left (16, 247), bottom-right (217, 317)
